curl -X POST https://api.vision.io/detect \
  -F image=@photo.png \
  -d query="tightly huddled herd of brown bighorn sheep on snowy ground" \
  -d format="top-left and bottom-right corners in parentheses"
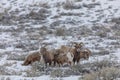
top-left (22, 42), bottom-right (91, 67)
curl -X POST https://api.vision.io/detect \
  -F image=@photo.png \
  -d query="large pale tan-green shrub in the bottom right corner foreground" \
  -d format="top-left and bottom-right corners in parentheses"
top-left (83, 67), bottom-right (120, 80)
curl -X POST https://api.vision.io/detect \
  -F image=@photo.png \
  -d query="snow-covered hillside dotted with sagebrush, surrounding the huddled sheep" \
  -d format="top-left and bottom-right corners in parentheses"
top-left (0, 0), bottom-right (120, 80)
